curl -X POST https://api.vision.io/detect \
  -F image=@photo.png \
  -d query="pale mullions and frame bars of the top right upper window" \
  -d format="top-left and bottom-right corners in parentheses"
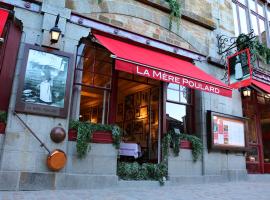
top-left (232, 0), bottom-right (270, 47)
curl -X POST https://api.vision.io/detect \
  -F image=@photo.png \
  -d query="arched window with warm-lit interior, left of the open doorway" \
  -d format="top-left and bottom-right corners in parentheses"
top-left (74, 42), bottom-right (113, 124)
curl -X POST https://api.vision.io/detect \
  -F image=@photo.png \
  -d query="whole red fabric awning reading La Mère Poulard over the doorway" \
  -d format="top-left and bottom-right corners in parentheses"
top-left (94, 33), bottom-right (232, 97)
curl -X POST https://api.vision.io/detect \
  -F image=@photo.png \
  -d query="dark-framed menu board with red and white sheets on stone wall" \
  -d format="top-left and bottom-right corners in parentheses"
top-left (207, 111), bottom-right (246, 151)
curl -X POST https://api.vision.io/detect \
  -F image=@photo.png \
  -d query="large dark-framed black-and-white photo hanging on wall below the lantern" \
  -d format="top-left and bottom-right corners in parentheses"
top-left (15, 44), bottom-right (73, 118)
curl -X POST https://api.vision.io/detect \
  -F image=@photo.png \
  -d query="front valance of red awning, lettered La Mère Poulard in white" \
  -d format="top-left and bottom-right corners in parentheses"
top-left (116, 60), bottom-right (232, 97)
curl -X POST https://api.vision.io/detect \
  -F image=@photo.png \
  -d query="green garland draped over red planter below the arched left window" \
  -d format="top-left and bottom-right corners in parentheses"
top-left (69, 120), bottom-right (122, 158)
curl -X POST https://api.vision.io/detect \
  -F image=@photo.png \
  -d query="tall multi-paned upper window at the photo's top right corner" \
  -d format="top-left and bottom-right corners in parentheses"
top-left (232, 0), bottom-right (270, 46)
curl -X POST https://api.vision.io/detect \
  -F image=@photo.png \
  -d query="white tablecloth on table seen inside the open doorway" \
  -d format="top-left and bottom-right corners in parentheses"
top-left (119, 142), bottom-right (142, 158)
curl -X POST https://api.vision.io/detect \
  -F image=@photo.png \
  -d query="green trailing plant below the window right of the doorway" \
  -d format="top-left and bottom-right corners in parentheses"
top-left (168, 131), bottom-right (203, 162)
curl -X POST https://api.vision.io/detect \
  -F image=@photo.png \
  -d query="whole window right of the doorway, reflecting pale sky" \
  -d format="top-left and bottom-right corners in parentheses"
top-left (166, 83), bottom-right (193, 134)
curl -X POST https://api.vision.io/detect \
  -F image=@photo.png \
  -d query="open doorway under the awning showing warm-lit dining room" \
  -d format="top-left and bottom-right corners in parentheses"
top-left (116, 72), bottom-right (161, 163)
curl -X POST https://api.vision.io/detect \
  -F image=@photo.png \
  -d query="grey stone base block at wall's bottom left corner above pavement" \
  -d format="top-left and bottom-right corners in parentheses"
top-left (0, 171), bottom-right (20, 191)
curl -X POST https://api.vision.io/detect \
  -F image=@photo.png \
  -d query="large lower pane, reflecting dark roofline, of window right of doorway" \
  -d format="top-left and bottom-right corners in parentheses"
top-left (166, 102), bottom-right (187, 133)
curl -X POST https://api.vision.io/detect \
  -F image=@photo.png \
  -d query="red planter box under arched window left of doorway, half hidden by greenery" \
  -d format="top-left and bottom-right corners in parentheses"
top-left (68, 129), bottom-right (113, 144)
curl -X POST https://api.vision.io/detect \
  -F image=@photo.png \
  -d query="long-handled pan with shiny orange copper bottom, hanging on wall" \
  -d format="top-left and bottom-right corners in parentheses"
top-left (13, 112), bottom-right (67, 171)
